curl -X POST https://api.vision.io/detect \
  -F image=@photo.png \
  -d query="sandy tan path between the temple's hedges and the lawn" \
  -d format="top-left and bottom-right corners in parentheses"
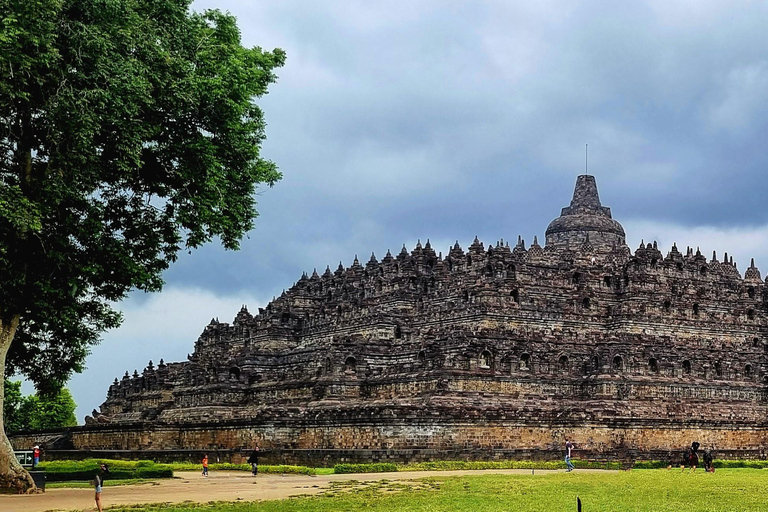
top-left (0, 469), bottom-right (596, 512)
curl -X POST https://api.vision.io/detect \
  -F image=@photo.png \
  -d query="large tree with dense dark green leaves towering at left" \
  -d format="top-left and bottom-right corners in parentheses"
top-left (0, 0), bottom-right (285, 490)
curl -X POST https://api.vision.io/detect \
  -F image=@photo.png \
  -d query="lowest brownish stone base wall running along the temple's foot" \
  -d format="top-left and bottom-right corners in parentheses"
top-left (11, 421), bottom-right (768, 465)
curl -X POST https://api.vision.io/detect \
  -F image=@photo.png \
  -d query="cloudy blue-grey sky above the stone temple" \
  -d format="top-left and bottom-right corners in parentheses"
top-left (45, 0), bottom-right (768, 422)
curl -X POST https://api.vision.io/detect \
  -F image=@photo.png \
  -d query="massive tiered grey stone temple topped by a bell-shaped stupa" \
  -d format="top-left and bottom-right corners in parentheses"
top-left (40, 175), bottom-right (768, 462)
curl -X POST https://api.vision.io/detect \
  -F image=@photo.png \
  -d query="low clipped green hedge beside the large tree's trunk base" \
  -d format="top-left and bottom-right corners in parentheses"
top-left (38, 459), bottom-right (173, 482)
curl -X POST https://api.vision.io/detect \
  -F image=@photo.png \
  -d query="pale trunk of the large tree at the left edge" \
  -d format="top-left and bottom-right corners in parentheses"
top-left (0, 315), bottom-right (37, 493)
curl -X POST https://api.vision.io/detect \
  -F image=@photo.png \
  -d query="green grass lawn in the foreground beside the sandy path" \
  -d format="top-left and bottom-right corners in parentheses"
top-left (105, 469), bottom-right (768, 512)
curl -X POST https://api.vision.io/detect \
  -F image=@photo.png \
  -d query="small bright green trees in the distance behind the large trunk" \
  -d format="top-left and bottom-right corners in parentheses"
top-left (3, 380), bottom-right (77, 432)
